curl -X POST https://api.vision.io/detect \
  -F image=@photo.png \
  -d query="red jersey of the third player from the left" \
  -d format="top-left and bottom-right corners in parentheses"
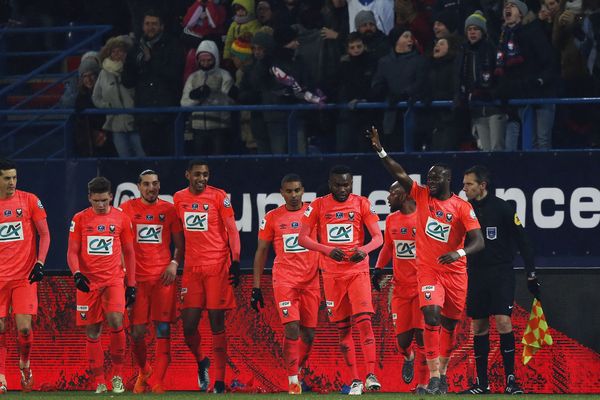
top-left (121, 199), bottom-right (181, 282)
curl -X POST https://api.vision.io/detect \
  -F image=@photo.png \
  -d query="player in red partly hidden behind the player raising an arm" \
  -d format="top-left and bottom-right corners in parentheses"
top-left (372, 182), bottom-right (429, 394)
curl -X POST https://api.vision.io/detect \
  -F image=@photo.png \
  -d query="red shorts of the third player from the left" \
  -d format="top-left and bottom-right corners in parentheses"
top-left (131, 278), bottom-right (177, 325)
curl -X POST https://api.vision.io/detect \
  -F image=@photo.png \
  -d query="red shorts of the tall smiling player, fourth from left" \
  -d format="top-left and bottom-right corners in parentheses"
top-left (181, 261), bottom-right (235, 310)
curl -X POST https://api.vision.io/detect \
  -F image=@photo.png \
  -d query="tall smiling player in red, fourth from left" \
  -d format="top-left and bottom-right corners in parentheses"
top-left (173, 160), bottom-right (240, 393)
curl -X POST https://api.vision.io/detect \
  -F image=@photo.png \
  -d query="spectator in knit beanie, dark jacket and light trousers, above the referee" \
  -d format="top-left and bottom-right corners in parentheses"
top-left (458, 11), bottom-right (506, 151)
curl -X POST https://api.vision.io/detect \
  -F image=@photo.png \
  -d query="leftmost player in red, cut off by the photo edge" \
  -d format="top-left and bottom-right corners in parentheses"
top-left (0, 159), bottom-right (50, 394)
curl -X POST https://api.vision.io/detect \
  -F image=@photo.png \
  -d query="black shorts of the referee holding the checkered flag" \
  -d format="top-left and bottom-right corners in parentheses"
top-left (467, 264), bottom-right (515, 319)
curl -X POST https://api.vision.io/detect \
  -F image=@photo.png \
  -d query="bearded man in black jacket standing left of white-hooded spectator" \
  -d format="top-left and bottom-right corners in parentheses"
top-left (121, 10), bottom-right (184, 156)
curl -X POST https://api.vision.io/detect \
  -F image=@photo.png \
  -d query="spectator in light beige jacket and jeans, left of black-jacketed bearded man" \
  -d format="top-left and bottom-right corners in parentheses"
top-left (92, 36), bottom-right (145, 157)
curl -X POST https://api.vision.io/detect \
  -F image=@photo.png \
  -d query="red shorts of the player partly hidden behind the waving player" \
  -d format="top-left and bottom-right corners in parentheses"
top-left (392, 286), bottom-right (425, 335)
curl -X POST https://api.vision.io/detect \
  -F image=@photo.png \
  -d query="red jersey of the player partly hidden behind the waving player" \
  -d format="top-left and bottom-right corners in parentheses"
top-left (383, 211), bottom-right (417, 291)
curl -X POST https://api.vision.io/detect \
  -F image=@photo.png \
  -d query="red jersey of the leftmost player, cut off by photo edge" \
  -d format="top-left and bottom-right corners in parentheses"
top-left (0, 190), bottom-right (46, 281)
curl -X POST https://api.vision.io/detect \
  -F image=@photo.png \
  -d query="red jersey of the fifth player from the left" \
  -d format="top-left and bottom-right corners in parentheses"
top-left (258, 203), bottom-right (319, 288)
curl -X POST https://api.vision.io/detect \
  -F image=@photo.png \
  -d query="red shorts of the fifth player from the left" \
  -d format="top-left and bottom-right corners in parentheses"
top-left (273, 286), bottom-right (321, 328)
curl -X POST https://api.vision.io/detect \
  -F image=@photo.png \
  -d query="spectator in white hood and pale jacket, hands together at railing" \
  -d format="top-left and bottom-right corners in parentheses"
top-left (181, 40), bottom-right (233, 155)
